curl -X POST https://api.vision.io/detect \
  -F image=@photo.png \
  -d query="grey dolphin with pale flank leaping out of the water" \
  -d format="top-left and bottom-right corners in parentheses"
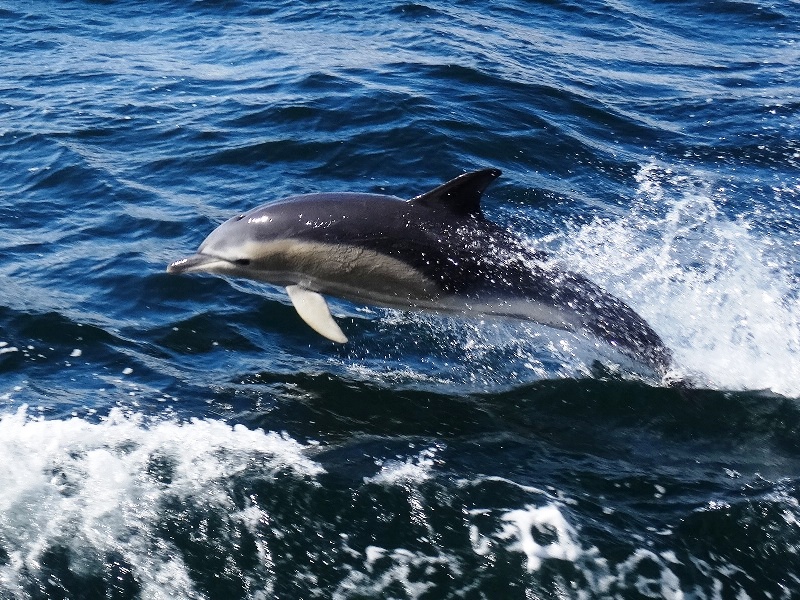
top-left (167, 169), bottom-right (671, 375)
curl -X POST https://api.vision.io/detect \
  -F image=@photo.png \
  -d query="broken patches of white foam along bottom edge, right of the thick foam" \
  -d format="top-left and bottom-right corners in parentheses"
top-left (332, 490), bottom-right (764, 600)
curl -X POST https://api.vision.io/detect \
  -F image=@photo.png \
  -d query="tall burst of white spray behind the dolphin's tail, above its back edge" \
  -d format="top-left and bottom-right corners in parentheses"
top-left (547, 164), bottom-right (800, 396)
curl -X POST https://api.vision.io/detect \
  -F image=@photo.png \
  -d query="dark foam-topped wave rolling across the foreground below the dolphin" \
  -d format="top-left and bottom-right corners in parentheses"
top-left (0, 407), bottom-right (798, 599)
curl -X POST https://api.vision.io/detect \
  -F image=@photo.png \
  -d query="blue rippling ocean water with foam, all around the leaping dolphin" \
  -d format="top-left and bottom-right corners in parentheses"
top-left (0, 0), bottom-right (800, 599)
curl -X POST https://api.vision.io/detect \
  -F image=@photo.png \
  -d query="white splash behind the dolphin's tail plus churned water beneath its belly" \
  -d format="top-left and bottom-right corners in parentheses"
top-left (345, 163), bottom-right (800, 397)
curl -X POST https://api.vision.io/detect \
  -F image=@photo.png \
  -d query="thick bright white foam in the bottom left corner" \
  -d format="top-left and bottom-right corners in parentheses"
top-left (0, 407), bottom-right (322, 599)
